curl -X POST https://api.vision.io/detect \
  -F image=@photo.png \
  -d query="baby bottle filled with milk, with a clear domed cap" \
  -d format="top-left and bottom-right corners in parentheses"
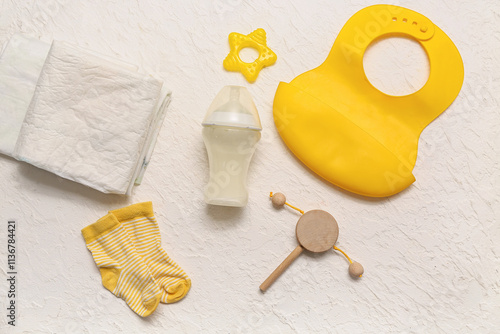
top-left (202, 86), bottom-right (262, 207)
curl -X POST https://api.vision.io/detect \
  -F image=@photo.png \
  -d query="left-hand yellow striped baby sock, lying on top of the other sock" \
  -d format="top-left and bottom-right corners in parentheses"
top-left (82, 214), bottom-right (161, 317)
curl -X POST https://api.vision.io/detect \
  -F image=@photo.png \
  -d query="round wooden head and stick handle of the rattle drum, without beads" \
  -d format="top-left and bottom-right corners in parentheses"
top-left (260, 210), bottom-right (339, 291)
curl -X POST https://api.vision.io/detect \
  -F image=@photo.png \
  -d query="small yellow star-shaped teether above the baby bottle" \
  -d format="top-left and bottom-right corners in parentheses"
top-left (222, 28), bottom-right (278, 82)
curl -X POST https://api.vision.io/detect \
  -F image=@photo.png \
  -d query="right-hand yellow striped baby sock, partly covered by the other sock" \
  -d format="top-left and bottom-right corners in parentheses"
top-left (110, 202), bottom-right (191, 303)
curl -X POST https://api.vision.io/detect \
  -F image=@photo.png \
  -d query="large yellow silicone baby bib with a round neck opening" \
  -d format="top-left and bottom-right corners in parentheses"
top-left (273, 5), bottom-right (464, 197)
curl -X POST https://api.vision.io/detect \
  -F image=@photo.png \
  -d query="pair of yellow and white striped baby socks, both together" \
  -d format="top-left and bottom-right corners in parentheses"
top-left (82, 202), bottom-right (191, 317)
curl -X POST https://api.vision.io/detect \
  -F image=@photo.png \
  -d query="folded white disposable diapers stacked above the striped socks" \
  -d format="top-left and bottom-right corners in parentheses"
top-left (0, 35), bottom-right (170, 194)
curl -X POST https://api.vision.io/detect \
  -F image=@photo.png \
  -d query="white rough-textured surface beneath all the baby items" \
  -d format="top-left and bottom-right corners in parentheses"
top-left (0, 0), bottom-right (500, 333)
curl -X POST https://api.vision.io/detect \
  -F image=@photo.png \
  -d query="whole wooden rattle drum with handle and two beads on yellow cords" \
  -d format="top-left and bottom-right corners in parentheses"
top-left (260, 192), bottom-right (364, 292)
